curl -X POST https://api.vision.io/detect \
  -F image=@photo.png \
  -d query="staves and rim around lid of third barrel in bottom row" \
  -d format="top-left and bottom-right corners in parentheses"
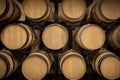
top-left (59, 50), bottom-right (86, 80)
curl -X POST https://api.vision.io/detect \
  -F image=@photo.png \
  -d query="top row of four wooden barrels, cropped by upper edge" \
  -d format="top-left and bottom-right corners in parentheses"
top-left (0, 0), bottom-right (120, 23)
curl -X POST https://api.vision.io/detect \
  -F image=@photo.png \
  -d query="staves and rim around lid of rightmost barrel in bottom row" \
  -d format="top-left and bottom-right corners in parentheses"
top-left (91, 50), bottom-right (120, 80)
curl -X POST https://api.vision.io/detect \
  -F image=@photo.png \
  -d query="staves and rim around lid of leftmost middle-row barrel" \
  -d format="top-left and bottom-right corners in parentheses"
top-left (1, 23), bottom-right (35, 50)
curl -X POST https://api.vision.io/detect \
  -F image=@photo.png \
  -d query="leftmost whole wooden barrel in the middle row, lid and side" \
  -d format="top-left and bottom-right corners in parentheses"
top-left (1, 23), bottom-right (35, 50)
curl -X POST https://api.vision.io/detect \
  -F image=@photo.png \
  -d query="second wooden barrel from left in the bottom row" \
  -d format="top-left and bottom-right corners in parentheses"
top-left (22, 51), bottom-right (52, 80)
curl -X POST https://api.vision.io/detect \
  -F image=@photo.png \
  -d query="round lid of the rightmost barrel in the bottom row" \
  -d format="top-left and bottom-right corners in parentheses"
top-left (100, 56), bottom-right (120, 79)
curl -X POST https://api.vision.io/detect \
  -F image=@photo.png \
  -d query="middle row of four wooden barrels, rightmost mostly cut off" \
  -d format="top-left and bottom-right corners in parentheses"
top-left (0, 23), bottom-right (120, 50)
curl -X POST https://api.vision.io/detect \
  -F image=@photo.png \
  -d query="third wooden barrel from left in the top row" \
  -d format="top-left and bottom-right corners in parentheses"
top-left (59, 0), bottom-right (86, 22)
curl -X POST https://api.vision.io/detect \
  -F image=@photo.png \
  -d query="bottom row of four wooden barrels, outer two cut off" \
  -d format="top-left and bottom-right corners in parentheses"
top-left (0, 49), bottom-right (120, 80)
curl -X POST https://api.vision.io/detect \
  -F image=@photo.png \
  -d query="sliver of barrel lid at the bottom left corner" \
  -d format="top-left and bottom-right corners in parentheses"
top-left (0, 57), bottom-right (7, 79)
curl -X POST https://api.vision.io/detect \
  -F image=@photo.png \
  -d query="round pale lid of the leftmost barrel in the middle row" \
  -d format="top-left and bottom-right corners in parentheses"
top-left (1, 24), bottom-right (28, 49)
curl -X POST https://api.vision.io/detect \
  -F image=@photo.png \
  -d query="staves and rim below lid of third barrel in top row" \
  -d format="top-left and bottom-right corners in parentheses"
top-left (58, 1), bottom-right (87, 22)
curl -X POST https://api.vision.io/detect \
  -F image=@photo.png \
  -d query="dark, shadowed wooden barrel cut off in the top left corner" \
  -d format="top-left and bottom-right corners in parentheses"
top-left (0, 0), bottom-right (21, 22)
